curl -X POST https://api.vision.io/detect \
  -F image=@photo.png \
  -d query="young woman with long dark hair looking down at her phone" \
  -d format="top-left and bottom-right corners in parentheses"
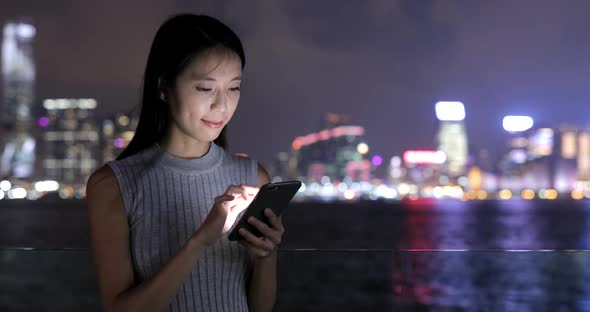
top-left (87, 14), bottom-right (284, 311)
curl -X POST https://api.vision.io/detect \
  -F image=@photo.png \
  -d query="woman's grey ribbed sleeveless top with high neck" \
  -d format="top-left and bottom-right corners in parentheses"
top-left (108, 143), bottom-right (258, 311)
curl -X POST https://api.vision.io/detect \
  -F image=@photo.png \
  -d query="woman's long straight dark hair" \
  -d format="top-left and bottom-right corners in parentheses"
top-left (117, 14), bottom-right (246, 159)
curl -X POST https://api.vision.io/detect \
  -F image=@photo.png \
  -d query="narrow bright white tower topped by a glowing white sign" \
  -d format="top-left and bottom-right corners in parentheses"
top-left (435, 102), bottom-right (468, 178)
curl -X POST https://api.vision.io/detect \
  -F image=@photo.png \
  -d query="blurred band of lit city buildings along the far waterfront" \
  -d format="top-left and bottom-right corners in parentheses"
top-left (0, 99), bottom-right (590, 200)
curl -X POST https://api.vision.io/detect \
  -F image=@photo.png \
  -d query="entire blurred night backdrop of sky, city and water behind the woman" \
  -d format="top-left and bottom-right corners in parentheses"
top-left (0, 0), bottom-right (590, 311)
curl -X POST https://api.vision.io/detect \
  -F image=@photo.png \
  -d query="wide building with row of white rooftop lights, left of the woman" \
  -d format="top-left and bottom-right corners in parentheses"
top-left (38, 99), bottom-right (100, 185)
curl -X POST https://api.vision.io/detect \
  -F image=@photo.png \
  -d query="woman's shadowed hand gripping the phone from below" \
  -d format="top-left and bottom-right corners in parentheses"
top-left (240, 208), bottom-right (285, 258)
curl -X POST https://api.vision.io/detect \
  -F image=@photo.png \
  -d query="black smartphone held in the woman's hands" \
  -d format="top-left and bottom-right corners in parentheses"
top-left (228, 181), bottom-right (301, 241)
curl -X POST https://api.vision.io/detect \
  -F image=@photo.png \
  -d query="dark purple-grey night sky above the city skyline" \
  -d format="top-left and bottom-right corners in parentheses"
top-left (0, 0), bottom-right (590, 171)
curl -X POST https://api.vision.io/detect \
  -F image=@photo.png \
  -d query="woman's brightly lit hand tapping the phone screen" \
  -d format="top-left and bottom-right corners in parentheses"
top-left (193, 184), bottom-right (259, 246)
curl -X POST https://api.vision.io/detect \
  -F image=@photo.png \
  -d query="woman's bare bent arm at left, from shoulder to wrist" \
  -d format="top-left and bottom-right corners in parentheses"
top-left (87, 166), bottom-right (207, 311)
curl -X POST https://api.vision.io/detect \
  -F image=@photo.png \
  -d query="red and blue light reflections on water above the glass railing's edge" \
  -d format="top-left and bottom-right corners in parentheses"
top-left (399, 200), bottom-right (590, 251)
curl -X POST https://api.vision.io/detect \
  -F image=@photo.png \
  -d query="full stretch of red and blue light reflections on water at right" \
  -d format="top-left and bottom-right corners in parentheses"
top-left (393, 200), bottom-right (590, 311)
